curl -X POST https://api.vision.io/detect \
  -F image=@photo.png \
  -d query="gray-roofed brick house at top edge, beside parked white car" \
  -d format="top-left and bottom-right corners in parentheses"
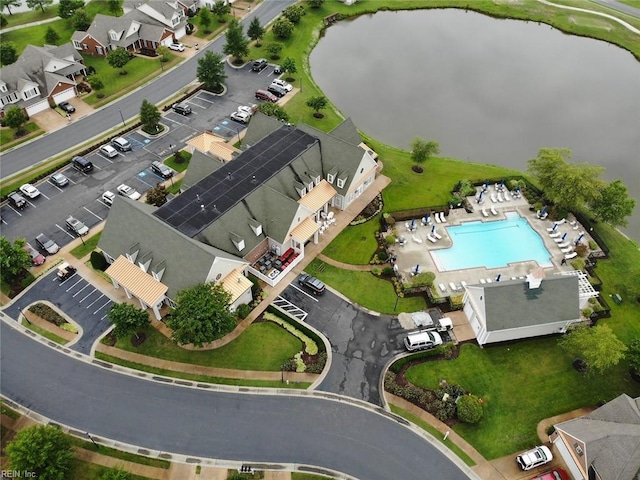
top-left (71, 0), bottom-right (187, 56)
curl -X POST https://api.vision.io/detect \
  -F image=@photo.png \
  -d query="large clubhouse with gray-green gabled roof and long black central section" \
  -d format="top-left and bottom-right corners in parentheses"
top-left (98, 114), bottom-right (375, 316)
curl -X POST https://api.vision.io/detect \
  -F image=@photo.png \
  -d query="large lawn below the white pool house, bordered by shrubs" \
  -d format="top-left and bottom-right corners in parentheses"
top-left (407, 338), bottom-right (640, 460)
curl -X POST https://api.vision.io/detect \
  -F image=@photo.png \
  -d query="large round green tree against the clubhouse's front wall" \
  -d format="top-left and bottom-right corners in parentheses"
top-left (167, 283), bottom-right (236, 347)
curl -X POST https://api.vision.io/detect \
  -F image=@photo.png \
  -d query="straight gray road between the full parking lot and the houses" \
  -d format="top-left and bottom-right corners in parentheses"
top-left (0, 0), bottom-right (295, 177)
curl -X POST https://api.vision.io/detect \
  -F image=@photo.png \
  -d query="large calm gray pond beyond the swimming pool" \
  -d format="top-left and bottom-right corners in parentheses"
top-left (310, 9), bottom-right (640, 244)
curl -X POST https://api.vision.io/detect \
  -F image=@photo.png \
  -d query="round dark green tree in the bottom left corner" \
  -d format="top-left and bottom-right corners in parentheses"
top-left (6, 425), bottom-right (73, 480)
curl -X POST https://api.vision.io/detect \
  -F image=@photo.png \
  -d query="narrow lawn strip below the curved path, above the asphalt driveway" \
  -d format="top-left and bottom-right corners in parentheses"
top-left (306, 259), bottom-right (425, 313)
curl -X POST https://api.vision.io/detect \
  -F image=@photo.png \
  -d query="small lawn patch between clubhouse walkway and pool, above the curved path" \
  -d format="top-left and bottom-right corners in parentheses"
top-left (322, 216), bottom-right (380, 265)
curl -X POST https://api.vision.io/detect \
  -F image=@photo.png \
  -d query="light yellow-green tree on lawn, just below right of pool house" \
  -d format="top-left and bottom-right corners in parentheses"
top-left (559, 324), bottom-right (627, 374)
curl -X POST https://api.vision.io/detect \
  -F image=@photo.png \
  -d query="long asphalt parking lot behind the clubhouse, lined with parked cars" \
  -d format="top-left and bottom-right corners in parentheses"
top-left (0, 64), bottom-right (284, 253)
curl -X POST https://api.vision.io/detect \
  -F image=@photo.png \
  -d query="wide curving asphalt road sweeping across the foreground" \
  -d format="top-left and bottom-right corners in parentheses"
top-left (0, 321), bottom-right (471, 480)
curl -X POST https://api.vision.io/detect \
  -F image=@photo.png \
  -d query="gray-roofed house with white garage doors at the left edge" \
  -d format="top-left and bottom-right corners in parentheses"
top-left (0, 43), bottom-right (86, 116)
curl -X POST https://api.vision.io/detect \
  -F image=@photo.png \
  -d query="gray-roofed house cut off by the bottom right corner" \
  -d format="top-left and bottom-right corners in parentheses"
top-left (549, 394), bottom-right (640, 480)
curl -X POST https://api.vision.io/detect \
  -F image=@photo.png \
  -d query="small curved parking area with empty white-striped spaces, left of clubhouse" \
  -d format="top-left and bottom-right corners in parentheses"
top-left (6, 269), bottom-right (113, 354)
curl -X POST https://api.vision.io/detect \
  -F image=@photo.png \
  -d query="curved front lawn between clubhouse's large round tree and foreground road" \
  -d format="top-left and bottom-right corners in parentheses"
top-left (108, 322), bottom-right (302, 371)
